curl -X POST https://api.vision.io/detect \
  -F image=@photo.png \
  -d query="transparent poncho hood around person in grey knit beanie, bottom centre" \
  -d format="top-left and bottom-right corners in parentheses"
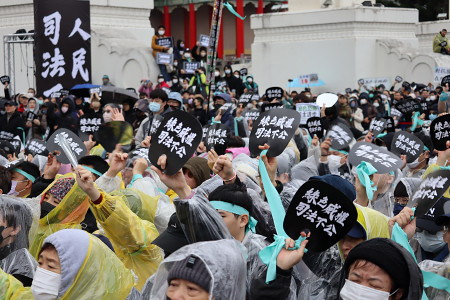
top-left (148, 239), bottom-right (246, 300)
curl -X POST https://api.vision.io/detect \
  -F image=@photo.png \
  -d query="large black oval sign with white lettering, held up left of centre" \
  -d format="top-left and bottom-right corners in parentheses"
top-left (148, 110), bottom-right (202, 176)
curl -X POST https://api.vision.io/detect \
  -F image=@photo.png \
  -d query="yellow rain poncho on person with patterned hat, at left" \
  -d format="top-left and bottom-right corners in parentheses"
top-left (30, 174), bottom-right (89, 259)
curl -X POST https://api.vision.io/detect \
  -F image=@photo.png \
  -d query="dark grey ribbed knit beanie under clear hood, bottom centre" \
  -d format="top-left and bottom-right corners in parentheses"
top-left (167, 255), bottom-right (212, 293)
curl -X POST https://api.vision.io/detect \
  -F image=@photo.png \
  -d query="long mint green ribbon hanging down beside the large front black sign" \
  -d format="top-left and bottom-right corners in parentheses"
top-left (259, 150), bottom-right (307, 283)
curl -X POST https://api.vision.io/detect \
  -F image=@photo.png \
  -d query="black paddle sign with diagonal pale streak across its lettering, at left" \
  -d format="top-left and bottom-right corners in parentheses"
top-left (46, 128), bottom-right (87, 164)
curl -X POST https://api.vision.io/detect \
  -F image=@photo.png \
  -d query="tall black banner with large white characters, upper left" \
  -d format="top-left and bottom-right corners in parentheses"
top-left (34, 0), bottom-right (91, 97)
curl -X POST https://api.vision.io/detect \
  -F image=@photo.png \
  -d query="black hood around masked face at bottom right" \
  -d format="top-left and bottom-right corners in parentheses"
top-left (344, 238), bottom-right (409, 291)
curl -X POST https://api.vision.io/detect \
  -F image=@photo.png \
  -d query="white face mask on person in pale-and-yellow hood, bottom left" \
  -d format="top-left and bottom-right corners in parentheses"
top-left (31, 267), bottom-right (61, 300)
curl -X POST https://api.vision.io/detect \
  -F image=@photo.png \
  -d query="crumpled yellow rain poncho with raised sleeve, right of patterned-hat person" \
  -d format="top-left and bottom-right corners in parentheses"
top-left (91, 190), bottom-right (162, 290)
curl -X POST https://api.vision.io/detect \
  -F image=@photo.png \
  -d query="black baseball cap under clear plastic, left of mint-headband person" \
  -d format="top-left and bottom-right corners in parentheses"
top-left (152, 213), bottom-right (189, 257)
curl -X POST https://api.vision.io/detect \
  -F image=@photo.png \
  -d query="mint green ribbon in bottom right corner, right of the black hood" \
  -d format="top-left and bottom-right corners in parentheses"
top-left (391, 218), bottom-right (450, 300)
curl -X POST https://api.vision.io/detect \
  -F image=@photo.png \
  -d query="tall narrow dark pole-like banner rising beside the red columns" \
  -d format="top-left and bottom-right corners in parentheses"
top-left (206, 0), bottom-right (223, 109)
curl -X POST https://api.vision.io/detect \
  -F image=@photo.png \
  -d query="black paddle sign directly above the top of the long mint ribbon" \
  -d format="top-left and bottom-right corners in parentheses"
top-left (249, 108), bottom-right (300, 157)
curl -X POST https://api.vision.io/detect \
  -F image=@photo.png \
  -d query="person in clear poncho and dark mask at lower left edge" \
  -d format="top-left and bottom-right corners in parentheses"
top-left (0, 195), bottom-right (37, 286)
